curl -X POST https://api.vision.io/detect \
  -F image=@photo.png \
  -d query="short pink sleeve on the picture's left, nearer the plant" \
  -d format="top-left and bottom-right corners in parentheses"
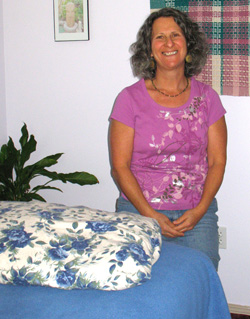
top-left (110, 89), bottom-right (135, 128)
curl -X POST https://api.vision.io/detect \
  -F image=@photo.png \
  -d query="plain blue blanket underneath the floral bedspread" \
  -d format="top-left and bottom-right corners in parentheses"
top-left (0, 242), bottom-right (231, 319)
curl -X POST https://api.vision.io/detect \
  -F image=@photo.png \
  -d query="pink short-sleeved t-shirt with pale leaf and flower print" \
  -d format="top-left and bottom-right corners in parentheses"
top-left (111, 78), bottom-right (226, 210)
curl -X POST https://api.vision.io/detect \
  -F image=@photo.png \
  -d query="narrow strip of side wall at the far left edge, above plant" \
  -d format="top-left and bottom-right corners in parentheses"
top-left (0, 0), bottom-right (7, 147)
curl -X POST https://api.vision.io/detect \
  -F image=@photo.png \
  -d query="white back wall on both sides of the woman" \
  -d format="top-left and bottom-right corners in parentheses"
top-left (0, 0), bottom-right (250, 306)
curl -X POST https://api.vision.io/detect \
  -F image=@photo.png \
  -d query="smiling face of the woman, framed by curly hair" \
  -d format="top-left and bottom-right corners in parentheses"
top-left (151, 17), bottom-right (187, 72)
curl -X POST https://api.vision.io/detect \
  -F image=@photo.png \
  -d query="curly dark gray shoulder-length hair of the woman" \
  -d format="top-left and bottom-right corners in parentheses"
top-left (130, 8), bottom-right (209, 79)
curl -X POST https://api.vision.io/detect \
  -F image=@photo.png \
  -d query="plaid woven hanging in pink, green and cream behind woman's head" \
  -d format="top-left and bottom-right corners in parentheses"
top-left (150, 0), bottom-right (250, 96)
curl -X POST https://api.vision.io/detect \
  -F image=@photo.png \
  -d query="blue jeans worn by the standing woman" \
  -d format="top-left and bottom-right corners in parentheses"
top-left (116, 196), bottom-right (220, 270)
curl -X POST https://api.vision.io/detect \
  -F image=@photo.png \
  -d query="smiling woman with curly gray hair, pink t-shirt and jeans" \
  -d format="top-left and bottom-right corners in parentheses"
top-left (110, 8), bottom-right (227, 269)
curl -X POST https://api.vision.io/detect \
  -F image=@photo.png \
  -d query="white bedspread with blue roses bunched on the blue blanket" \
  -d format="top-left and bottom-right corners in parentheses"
top-left (0, 201), bottom-right (161, 290)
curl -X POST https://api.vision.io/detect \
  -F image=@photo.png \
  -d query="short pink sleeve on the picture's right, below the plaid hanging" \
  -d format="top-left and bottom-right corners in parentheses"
top-left (208, 88), bottom-right (226, 126)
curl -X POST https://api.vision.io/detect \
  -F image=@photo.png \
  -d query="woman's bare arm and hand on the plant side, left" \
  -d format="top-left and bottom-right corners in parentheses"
top-left (110, 120), bottom-right (183, 237)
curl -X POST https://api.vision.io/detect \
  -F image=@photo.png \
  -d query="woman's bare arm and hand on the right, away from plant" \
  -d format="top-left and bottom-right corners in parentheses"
top-left (173, 116), bottom-right (227, 232)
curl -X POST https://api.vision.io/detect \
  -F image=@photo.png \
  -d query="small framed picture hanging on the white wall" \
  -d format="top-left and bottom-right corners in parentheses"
top-left (54, 0), bottom-right (89, 41)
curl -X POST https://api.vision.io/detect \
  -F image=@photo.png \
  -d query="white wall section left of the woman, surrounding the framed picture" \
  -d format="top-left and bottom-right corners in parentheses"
top-left (3, 0), bottom-right (149, 210)
